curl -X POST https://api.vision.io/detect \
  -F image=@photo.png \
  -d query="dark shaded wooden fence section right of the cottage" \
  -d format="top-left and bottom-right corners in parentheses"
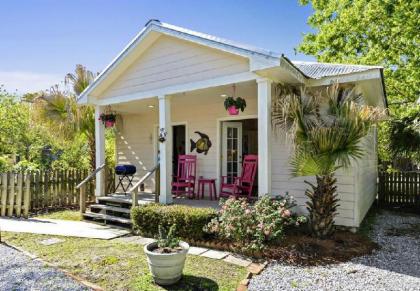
top-left (378, 172), bottom-right (420, 209)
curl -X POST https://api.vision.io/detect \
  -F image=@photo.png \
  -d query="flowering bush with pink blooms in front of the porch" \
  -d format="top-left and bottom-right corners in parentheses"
top-left (205, 195), bottom-right (306, 251)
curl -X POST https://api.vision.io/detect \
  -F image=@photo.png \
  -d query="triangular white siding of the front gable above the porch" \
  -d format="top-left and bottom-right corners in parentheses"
top-left (101, 36), bottom-right (249, 98)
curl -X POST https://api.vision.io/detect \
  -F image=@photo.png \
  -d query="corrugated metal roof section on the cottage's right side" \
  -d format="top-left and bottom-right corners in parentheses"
top-left (291, 61), bottom-right (382, 79)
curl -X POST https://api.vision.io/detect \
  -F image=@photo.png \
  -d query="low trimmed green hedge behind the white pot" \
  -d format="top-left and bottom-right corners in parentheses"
top-left (131, 203), bottom-right (217, 240)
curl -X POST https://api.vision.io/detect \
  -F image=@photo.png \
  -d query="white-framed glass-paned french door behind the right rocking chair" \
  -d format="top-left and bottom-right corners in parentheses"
top-left (222, 122), bottom-right (242, 183)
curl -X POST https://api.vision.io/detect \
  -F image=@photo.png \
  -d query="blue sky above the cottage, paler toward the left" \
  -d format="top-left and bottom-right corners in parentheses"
top-left (0, 0), bottom-right (314, 94)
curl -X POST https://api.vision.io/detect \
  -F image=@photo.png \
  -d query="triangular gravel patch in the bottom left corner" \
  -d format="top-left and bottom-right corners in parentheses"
top-left (0, 243), bottom-right (90, 291)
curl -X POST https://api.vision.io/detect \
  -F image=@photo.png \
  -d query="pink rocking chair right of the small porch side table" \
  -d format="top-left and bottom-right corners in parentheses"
top-left (219, 155), bottom-right (258, 199)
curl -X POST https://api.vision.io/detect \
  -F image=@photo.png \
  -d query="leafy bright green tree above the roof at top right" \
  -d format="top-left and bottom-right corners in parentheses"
top-left (297, 0), bottom-right (420, 104)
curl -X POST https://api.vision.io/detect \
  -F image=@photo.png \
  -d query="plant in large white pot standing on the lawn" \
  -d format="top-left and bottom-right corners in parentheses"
top-left (144, 224), bottom-right (190, 285)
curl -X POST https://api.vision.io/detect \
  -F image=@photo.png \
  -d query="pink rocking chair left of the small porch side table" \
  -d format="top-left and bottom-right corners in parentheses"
top-left (171, 155), bottom-right (197, 198)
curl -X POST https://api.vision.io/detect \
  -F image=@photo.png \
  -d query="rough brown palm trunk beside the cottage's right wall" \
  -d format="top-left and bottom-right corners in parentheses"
top-left (305, 174), bottom-right (338, 239)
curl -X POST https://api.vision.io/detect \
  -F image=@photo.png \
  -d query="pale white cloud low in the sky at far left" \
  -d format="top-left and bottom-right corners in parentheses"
top-left (0, 71), bottom-right (64, 94)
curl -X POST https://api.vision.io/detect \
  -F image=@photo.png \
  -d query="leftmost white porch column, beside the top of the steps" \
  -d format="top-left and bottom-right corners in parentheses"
top-left (95, 105), bottom-right (106, 196)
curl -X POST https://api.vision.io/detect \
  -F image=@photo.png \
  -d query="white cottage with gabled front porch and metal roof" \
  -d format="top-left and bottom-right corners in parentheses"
top-left (78, 20), bottom-right (386, 227)
